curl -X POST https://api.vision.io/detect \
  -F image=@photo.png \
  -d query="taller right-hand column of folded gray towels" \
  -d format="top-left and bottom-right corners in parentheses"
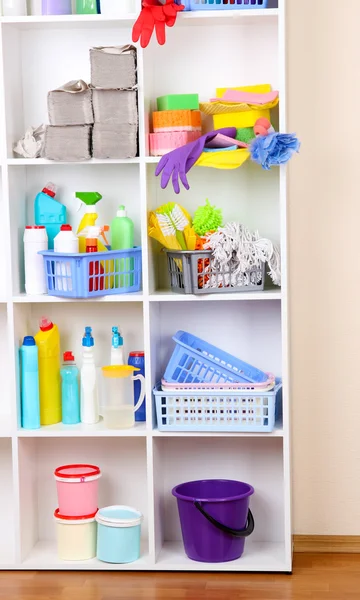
top-left (90, 46), bottom-right (138, 159)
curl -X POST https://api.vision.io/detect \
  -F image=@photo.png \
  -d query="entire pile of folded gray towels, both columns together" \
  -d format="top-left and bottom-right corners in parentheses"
top-left (43, 46), bottom-right (138, 161)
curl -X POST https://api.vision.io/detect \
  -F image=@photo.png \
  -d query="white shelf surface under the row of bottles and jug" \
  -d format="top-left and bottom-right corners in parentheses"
top-left (17, 420), bottom-right (146, 438)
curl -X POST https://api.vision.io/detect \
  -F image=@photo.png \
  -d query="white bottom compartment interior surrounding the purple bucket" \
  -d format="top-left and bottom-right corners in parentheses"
top-left (153, 437), bottom-right (286, 571)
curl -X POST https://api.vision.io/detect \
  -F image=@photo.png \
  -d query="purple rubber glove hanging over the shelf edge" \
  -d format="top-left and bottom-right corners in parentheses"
top-left (155, 127), bottom-right (236, 194)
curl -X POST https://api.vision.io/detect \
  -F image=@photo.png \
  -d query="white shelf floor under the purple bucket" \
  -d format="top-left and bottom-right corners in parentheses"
top-left (156, 539), bottom-right (291, 573)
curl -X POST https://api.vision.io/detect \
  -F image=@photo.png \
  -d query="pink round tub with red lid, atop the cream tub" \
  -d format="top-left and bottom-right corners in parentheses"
top-left (54, 465), bottom-right (101, 517)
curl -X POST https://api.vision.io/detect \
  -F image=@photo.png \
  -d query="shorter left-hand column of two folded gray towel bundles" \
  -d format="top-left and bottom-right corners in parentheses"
top-left (44, 80), bottom-right (94, 161)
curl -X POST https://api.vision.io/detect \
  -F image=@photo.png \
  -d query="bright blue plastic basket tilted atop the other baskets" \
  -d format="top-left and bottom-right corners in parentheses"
top-left (164, 331), bottom-right (268, 383)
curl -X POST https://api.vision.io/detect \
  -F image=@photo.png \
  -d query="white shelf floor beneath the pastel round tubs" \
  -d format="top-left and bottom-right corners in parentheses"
top-left (21, 541), bottom-right (151, 571)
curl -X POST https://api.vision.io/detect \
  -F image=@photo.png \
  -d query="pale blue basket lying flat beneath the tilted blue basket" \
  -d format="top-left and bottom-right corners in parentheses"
top-left (154, 379), bottom-right (282, 433)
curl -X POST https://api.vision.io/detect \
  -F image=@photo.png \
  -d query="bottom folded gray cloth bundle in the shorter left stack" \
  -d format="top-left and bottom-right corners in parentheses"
top-left (44, 125), bottom-right (92, 161)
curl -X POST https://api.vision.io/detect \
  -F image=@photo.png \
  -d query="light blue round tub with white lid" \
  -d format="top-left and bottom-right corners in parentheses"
top-left (96, 506), bottom-right (143, 564)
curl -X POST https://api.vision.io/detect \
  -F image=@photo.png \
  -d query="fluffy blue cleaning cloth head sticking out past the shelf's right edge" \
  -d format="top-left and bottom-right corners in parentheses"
top-left (250, 132), bottom-right (300, 171)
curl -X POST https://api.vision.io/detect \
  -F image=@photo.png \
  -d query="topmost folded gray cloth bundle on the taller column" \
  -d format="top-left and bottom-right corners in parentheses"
top-left (90, 46), bottom-right (136, 90)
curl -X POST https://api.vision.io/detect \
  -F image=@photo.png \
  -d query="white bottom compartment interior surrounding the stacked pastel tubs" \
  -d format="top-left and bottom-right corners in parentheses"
top-left (18, 437), bottom-right (149, 569)
